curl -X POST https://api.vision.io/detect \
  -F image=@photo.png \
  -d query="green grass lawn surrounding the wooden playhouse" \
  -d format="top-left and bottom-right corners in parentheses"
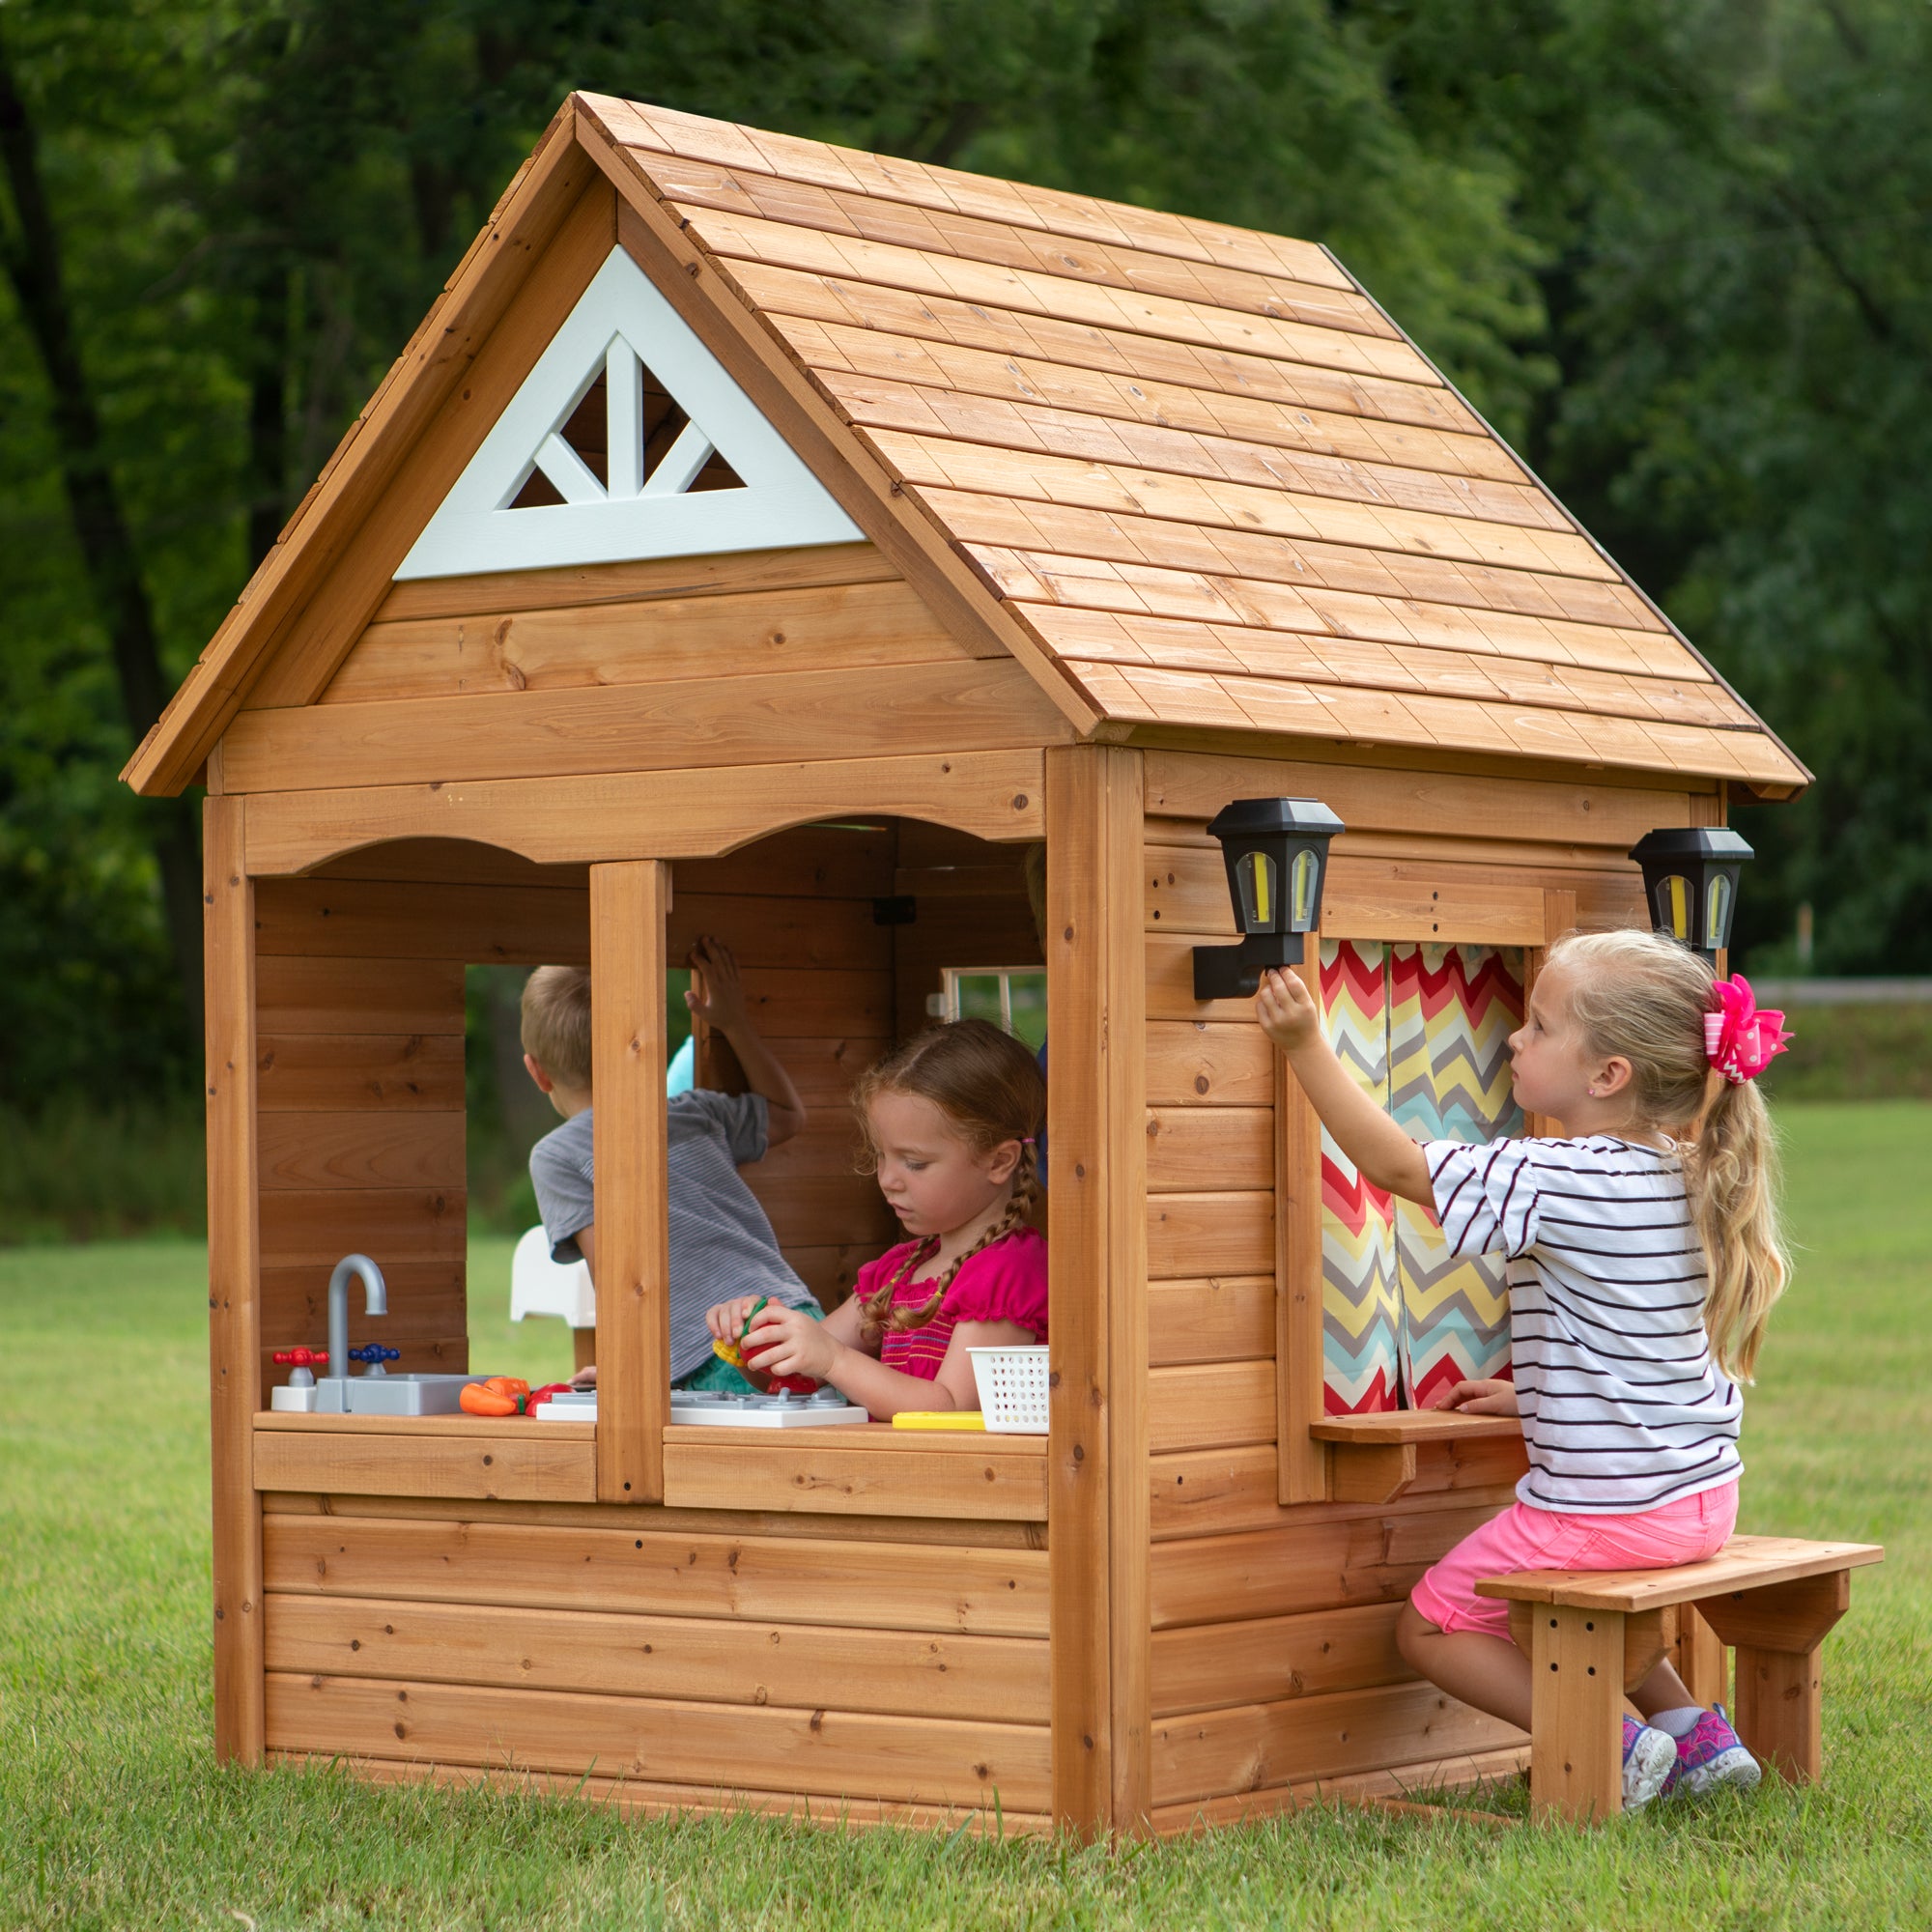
top-left (0, 1103), bottom-right (1932, 1932)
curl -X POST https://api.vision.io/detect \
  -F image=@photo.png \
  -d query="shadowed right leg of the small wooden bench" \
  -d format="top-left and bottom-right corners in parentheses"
top-left (1698, 1571), bottom-right (1851, 1783)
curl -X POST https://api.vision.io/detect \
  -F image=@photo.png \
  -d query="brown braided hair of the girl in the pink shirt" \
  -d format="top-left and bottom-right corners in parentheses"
top-left (852, 1020), bottom-right (1047, 1343)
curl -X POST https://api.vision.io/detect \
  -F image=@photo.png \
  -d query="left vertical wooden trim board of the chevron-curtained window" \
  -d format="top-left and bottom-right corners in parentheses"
top-left (1273, 931), bottom-right (1321, 1503)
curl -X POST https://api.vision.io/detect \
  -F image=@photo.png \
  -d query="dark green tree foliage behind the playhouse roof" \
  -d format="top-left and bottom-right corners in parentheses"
top-left (0, 0), bottom-right (1932, 1109)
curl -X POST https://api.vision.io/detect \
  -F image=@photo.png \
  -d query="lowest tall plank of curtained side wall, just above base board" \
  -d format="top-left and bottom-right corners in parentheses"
top-left (1151, 1683), bottom-right (1522, 1804)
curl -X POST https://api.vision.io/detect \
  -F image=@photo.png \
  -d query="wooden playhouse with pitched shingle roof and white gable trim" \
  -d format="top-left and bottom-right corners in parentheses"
top-left (128, 95), bottom-right (1804, 1830)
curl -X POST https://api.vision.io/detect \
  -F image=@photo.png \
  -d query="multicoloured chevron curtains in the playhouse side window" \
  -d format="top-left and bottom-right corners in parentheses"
top-left (1321, 941), bottom-right (1522, 1414)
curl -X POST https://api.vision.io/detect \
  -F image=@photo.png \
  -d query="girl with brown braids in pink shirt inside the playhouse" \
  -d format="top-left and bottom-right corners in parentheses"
top-left (707, 1020), bottom-right (1047, 1422)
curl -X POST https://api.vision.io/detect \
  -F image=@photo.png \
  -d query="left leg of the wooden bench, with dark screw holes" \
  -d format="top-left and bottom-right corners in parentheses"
top-left (1530, 1604), bottom-right (1623, 1824)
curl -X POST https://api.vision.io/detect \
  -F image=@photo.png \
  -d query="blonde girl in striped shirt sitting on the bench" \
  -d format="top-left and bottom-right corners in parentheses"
top-left (1256, 931), bottom-right (1789, 1806)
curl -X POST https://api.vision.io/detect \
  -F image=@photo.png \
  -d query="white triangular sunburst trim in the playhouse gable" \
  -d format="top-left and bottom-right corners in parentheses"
top-left (396, 247), bottom-right (862, 578)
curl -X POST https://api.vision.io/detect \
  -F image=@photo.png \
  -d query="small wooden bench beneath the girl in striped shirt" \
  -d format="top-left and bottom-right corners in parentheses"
top-left (1476, 1536), bottom-right (1886, 1822)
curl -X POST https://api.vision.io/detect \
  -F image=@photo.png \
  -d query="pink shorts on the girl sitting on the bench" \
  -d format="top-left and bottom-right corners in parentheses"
top-left (1408, 1480), bottom-right (1737, 1636)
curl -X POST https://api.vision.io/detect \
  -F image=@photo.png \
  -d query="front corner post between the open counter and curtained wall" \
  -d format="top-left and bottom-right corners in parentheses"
top-left (1047, 746), bottom-right (1153, 1833)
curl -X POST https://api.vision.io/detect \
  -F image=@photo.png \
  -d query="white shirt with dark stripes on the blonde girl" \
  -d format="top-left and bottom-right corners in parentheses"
top-left (1422, 1134), bottom-right (1745, 1517)
